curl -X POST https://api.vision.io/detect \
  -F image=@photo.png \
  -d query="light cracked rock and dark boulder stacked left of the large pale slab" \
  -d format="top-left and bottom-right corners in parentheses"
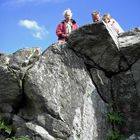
top-left (0, 48), bottom-right (40, 110)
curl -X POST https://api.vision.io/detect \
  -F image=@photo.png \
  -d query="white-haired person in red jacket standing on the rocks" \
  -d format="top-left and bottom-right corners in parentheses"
top-left (56, 9), bottom-right (78, 41)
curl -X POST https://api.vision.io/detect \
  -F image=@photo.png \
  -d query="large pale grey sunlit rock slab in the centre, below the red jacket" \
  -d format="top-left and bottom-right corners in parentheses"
top-left (19, 43), bottom-right (107, 140)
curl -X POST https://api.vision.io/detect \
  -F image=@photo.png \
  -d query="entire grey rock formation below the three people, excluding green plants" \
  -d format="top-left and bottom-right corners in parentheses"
top-left (0, 22), bottom-right (140, 140)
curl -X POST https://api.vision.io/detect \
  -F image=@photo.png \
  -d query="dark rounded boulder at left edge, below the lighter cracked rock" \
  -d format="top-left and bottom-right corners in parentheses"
top-left (0, 65), bottom-right (21, 105)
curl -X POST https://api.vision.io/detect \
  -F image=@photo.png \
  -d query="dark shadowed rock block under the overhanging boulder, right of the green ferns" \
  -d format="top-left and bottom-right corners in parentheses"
top-left (111, 71), bottom-right (140, 135)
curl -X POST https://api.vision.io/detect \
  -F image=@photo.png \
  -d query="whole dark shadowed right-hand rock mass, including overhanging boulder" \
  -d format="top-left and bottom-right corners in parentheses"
top-left (68, 22), bottom-right (140, 136)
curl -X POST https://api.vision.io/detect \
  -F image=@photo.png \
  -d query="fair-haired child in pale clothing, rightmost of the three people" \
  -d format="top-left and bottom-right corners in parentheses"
top-left (102, 13), bottom-right (124, 34)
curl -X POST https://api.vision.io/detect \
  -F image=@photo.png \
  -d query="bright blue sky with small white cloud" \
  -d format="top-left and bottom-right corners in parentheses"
top-left (0, 0), bottom-right (140, 54)
